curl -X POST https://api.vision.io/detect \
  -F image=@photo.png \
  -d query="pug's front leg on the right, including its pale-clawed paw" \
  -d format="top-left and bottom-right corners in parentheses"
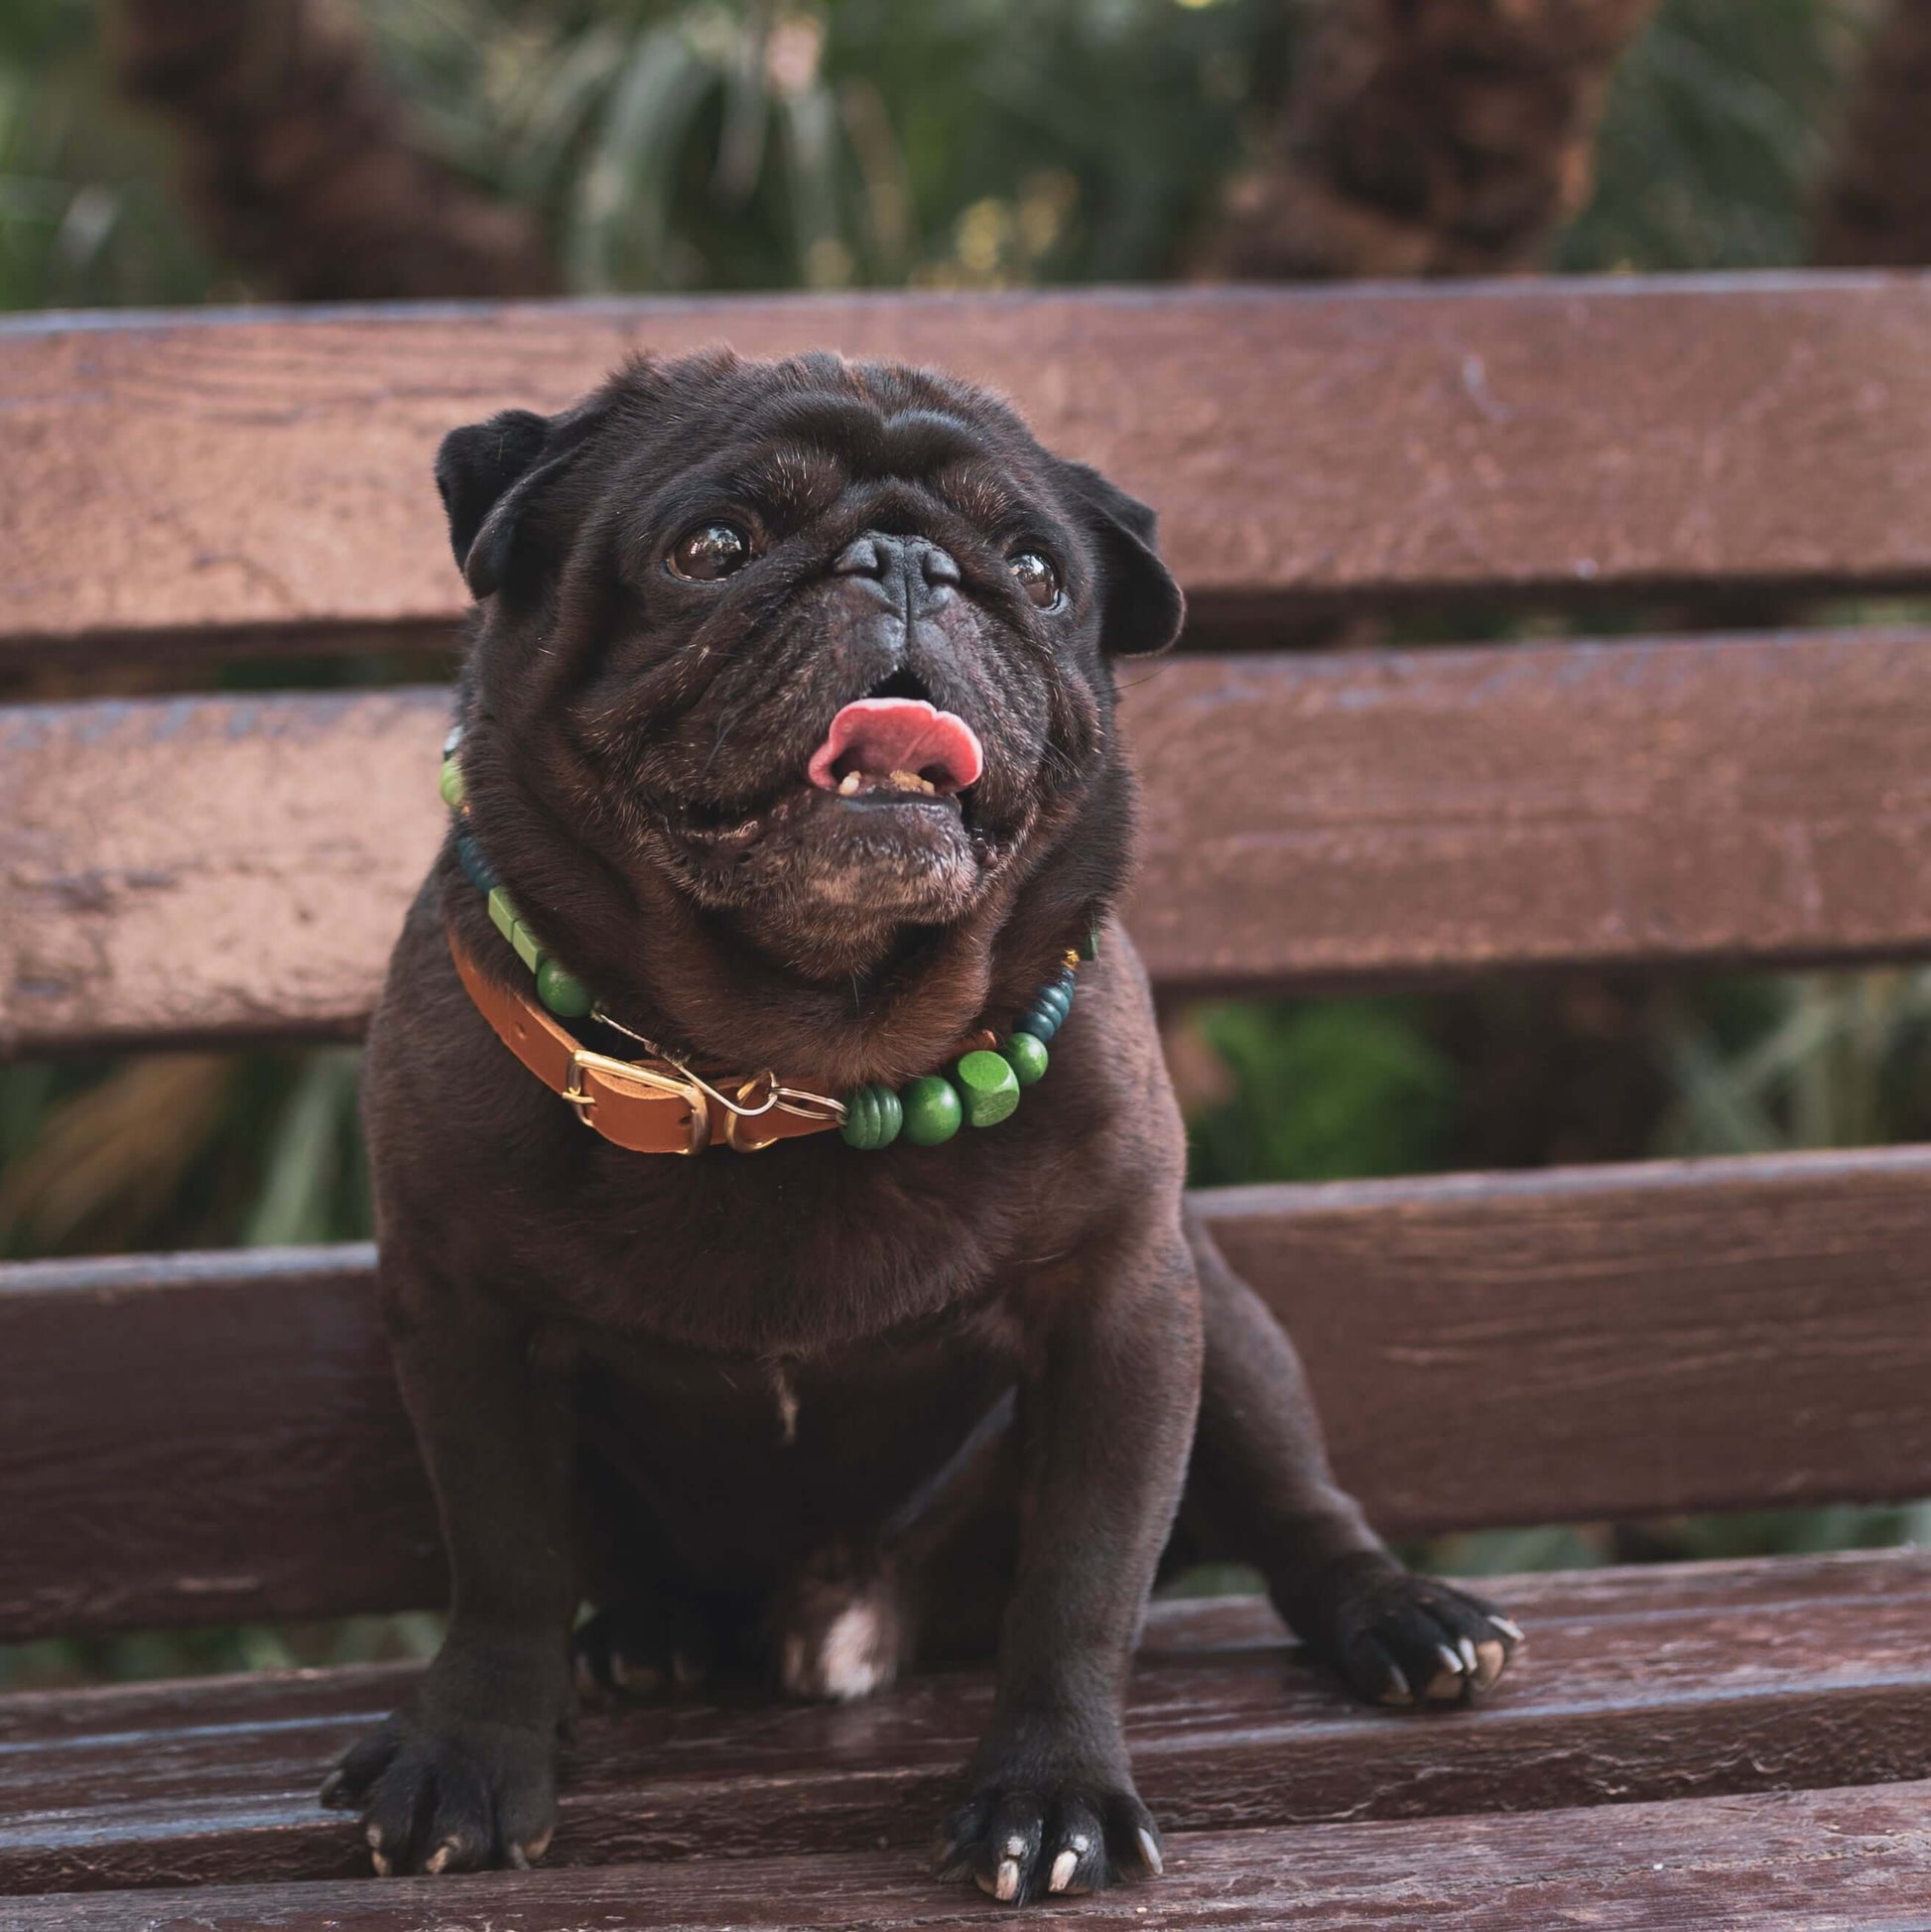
top-left (942, 1224), bottom-right (1201, 1901)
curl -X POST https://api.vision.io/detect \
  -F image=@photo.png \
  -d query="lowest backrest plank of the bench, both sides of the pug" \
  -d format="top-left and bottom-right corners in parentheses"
top-left (0, 1148), bottom-right (1931, 1638)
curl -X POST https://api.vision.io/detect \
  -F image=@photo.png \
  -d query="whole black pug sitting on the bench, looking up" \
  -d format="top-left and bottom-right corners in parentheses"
top-left (322, 351), bottom-right (1519, 1901)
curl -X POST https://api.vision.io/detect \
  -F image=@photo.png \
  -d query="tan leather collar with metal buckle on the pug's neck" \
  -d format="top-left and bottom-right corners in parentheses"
top-left (449, 933), bottom-right (842, 1153)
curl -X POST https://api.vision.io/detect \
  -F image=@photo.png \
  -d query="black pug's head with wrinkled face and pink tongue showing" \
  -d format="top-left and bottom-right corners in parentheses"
top-left (437, 351), bottom-right (1181, 1066)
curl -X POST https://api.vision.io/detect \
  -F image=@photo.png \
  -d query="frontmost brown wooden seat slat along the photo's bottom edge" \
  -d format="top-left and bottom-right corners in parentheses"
top-left (11, 1783), bottom-right (1931, 1932)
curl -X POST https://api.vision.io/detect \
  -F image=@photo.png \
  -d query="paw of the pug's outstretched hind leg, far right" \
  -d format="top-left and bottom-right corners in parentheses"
top-left (1309, 1561), bottom-right (1523, 1708)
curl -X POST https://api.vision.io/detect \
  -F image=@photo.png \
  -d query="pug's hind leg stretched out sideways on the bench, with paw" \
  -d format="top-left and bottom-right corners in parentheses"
top-left (1181, 1212), bottom-right (1521, 1706)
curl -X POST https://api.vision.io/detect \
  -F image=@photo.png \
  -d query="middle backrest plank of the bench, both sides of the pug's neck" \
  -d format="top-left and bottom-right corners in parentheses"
top-left (15, 632), bottom-right (1931, 1051)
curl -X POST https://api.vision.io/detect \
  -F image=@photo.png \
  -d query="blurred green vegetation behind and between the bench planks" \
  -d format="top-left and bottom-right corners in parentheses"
top-left (0, 0), bottom-right (1931, 1683)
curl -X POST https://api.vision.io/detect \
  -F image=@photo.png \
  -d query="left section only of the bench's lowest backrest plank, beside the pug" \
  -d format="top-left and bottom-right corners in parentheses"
top-left (0, 1248), bottom-right (443, 1636)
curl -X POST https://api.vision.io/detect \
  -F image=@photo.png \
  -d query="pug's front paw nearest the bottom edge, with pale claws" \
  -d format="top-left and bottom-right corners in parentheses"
top-left (936, 1771), bottom-right (1162, 1905)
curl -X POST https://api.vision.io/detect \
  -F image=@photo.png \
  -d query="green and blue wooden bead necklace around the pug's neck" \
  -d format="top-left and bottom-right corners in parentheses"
top-left (441, 724), bottom-right (1099, 1151)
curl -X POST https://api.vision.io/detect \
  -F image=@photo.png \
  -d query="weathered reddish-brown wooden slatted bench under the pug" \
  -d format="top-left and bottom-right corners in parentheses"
top-left (0, 278), bottom-right (1931, 1932)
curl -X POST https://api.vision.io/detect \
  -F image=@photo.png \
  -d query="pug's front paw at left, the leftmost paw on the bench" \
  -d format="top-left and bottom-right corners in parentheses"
top-left (321, 1712), bottom-right (557, 1877)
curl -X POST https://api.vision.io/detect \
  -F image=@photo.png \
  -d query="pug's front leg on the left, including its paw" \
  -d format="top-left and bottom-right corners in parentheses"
top-left (322, 1250), bottom-right (575, 1876)
